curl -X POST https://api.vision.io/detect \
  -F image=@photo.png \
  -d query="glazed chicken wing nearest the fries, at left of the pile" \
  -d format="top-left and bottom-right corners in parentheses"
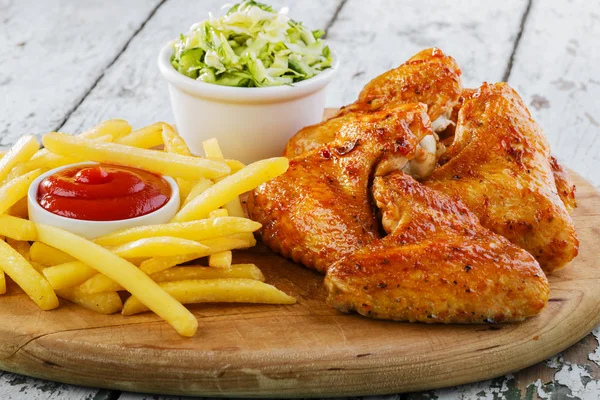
top-left (248, 104), bottom-right (431, 272)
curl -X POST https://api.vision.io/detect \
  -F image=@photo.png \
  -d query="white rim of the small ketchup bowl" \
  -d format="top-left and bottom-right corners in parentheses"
top-left (27, 161), bottom-right (181, 226)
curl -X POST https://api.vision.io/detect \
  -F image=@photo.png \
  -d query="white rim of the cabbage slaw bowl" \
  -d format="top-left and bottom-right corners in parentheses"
top-left (157, 40), bottom-right (339, 102)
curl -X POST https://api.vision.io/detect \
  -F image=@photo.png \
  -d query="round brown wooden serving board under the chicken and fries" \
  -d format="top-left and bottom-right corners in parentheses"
top-left (0, 178), bottom-right (600, 397)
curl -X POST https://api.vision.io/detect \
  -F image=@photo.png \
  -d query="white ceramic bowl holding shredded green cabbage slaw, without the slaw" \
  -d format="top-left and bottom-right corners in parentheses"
top-left (158, 42), bottom-right (338, 163)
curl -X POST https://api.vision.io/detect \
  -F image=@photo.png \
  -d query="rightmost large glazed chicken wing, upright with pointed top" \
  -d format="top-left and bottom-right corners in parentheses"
top-left (425, 83), bottom-right (578, 272)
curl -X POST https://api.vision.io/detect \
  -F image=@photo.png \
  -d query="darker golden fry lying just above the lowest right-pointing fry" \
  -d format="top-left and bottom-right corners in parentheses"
top-left (150, 264), bottom-right (265, 283)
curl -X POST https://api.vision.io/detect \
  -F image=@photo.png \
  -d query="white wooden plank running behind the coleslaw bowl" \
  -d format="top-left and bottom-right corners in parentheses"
top-left (63, 0), bottom-right (341, 132)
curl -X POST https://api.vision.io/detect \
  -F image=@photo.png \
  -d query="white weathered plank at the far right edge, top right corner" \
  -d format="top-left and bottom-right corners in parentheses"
top-left (509, 0), bottom-right (600, 187)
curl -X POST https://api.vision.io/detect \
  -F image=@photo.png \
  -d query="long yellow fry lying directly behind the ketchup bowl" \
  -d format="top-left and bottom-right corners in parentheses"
top-left (42, 133), bottom-right (230, 180)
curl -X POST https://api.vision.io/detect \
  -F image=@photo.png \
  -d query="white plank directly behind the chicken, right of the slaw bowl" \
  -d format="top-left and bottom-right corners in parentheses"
top-left (327, 0), bottom-right (527, 106)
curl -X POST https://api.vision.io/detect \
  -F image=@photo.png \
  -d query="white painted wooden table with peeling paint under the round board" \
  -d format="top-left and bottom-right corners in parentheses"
top-left (0, 0), bottom-right (600, 400)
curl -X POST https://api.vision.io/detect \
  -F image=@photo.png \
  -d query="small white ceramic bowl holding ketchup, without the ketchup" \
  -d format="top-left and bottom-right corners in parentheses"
top-left (27, 162), bottom-right (180, 239)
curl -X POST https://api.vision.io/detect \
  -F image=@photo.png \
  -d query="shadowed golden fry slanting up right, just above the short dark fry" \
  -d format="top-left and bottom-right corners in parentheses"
top-left (140, 237), bottom-right (256, 274)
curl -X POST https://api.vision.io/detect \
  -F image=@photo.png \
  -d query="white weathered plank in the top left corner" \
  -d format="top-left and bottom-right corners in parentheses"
top-left (0, 0), bottom-right (158, 146)
